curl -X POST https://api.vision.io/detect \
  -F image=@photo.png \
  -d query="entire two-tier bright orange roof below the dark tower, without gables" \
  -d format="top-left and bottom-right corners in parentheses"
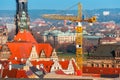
top-left (7, 30), bottom-right (53, 59)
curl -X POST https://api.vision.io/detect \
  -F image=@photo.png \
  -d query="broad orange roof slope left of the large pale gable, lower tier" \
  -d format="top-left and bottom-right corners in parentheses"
top-left (7, 42), bottom-right (33, 59)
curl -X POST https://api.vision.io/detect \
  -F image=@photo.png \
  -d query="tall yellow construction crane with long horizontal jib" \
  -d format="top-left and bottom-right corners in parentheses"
top-left (42, 3), bottom-right (96, 74)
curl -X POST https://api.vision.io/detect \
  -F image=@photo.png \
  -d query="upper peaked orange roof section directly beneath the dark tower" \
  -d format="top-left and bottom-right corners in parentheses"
top-left (14, 30), bottom-right (37, 43)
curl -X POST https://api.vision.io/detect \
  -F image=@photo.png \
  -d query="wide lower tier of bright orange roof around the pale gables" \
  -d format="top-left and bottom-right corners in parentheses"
top-left (7, 42), bottom-right (53, 59)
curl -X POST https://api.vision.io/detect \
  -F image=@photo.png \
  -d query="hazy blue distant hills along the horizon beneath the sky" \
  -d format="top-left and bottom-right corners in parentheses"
top-left (0, 8), bottom-right (120, 24)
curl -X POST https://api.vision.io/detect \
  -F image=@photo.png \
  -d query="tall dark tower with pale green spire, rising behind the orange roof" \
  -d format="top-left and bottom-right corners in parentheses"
top-left (15, 0), bottom-right (30, 34)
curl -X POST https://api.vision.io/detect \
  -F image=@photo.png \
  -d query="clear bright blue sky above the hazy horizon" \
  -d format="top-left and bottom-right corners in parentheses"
top-left (0, 0), bottom-right (120, 10)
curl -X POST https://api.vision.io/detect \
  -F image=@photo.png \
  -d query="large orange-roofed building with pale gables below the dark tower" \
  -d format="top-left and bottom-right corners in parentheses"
top-left (0, 30), bottom-right (58, 62)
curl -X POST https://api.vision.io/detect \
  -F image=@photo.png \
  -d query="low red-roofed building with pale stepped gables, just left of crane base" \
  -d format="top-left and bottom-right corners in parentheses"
top-left (31, 59), bottom-right (77, 74)
